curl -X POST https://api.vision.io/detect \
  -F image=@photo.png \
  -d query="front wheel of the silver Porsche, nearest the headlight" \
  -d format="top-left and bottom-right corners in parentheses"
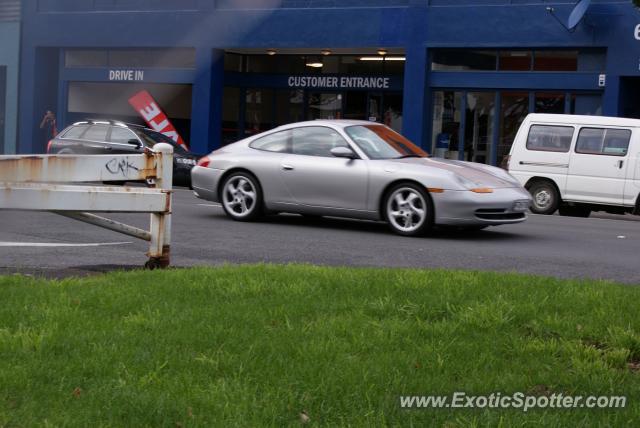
top-left (384, 183), bottom-right (433, 236)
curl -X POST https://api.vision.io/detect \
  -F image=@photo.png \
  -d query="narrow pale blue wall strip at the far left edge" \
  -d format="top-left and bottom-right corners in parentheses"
top-left (0, 22), bottom-right (20, 154)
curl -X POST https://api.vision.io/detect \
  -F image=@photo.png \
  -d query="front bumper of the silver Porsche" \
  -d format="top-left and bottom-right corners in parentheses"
top-left (431, 187), bottom-right (531, 226)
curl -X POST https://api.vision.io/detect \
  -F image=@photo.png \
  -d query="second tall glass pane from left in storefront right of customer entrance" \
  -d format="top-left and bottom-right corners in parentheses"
top-left (463, 92), bottom-right (496, 163)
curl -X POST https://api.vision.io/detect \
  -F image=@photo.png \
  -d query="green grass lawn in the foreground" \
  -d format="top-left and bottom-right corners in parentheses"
top-left (0, 266), bottom-right (640, 427)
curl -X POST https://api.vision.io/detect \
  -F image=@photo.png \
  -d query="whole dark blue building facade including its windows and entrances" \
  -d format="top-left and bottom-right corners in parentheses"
top-left (18, 0), bottom-right (640, 164)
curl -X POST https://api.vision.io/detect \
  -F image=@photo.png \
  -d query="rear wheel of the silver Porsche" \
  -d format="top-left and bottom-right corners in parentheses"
top-left (220, 172), bottom-right (262, 221)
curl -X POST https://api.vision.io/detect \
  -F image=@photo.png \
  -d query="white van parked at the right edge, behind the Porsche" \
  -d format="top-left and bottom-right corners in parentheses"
top-left (506, 114), bottom-right (640, 217)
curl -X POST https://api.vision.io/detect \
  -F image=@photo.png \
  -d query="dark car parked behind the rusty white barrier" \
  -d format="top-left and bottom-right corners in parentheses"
top-left (47, 120), bottom-right (198, 186)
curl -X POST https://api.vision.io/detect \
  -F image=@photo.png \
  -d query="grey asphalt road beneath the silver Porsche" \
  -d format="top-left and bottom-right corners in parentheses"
top-left (0, 189), bottom-right (640, 284)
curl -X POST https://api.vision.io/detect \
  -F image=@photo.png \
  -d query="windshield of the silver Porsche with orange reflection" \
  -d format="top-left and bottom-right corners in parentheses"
top-left (345, 125), bottom-right (429, 159)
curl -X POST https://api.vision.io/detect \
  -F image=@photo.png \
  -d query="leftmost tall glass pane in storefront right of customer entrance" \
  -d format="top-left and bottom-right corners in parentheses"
top-left (432, 91), bottom-right (463, 159)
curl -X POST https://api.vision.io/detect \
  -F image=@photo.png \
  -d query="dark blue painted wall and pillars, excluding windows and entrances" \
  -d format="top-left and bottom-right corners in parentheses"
top-left (19, 0), bottom-right (640, 152)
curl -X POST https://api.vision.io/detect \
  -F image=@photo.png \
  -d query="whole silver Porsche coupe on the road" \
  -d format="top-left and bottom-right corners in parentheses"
top-left (191, 120), bottom-right (531, 236)
